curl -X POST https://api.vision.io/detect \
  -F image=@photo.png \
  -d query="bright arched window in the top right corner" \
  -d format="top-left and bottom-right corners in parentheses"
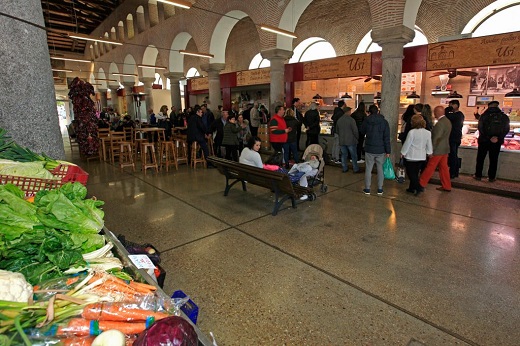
top-left (462, 0), bottom-right (520, 37)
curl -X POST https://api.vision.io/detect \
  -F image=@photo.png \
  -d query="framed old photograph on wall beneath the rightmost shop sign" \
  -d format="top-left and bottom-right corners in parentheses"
top-left (470, 65), bottom-right (520, 95)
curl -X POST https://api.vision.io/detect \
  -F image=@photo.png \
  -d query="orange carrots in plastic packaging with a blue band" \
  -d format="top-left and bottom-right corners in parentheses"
top-left (56, 318), bottom-right (147, 336)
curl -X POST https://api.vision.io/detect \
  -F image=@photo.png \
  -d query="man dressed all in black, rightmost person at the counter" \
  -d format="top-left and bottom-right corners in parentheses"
top-left (473, 101), bottom-right (509, 182)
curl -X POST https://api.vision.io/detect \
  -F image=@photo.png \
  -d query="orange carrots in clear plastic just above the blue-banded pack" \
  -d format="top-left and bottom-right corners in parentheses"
top-left (81, 303), bottom-right (169, 322)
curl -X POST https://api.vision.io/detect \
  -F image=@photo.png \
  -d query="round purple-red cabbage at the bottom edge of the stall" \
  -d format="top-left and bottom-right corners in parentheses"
top-left (134, 316), bottom-right (198, 346)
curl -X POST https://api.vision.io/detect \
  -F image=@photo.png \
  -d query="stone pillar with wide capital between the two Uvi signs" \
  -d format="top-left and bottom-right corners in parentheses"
top-left (372, 25), bottom-right (415, 162)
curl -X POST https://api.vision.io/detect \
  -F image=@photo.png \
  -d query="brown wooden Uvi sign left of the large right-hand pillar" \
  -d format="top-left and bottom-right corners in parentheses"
top-left (303, 53), bottom-right (372, 80)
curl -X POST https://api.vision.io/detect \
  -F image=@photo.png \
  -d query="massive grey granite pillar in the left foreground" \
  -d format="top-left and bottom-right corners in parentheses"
top-left (0, 0), bottom-right (65, 159)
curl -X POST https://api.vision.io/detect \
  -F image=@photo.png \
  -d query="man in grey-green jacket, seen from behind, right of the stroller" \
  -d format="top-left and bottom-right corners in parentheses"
top-left (336, 106), bottom-right (360, 173)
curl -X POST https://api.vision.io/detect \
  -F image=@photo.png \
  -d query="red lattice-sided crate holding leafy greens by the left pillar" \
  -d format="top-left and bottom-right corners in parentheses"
top-left (0, 165), bottom-right (88, 197)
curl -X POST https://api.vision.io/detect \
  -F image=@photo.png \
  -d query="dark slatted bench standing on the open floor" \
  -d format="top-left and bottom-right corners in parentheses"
top-left (208, 156), bottom-right (316, 216)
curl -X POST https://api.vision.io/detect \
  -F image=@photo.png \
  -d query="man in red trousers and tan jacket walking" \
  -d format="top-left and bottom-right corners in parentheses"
top-left (419, 106), bottom-right (451, 192)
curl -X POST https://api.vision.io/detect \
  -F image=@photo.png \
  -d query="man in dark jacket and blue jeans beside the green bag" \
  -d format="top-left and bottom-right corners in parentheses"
top-left (361, 105), bottom-right (392, 195)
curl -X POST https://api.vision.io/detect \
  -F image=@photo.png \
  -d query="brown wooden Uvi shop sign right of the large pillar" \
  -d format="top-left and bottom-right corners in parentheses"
top-left (426, 32), bottom-right (520, 71)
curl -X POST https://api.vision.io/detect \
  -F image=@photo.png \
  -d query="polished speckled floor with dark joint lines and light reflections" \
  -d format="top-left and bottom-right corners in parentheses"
top-left (67, 144), bottom-right (520, 346)
